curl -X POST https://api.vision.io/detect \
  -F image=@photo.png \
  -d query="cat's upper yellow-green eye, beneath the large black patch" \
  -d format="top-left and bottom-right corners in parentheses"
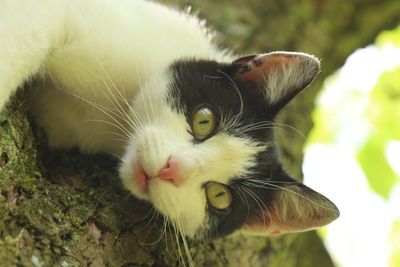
top-left (192, 107), bottom-right (216, 141)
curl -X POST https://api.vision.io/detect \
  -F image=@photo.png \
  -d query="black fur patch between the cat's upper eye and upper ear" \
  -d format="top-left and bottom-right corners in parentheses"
top-left (166, 60), bottom-right (272, 130)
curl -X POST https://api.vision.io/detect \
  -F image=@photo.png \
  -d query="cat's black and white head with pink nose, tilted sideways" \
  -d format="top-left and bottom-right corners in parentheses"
top-left (120, 52), bottom-right (339, 238)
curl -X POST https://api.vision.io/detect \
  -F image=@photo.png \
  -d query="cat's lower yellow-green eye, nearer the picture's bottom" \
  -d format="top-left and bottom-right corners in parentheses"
top-left (206, 182), bottom-right (232, 210)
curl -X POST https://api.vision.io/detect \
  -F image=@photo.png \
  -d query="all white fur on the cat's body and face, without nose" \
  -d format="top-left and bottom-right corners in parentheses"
top-left (0, 0), bottom-right (262, 239)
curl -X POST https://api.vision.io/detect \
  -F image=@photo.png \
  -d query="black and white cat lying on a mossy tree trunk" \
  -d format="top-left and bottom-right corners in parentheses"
top-left (0, 0), bottom-right (339, 241)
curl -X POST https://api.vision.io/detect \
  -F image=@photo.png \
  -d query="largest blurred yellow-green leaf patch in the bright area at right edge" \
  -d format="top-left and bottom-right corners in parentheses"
top-left (357, 68), bottom-right (400, 198)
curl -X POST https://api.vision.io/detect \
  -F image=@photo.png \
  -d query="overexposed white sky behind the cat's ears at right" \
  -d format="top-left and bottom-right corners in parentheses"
top-left (303, 46), bottom-right (400, 267)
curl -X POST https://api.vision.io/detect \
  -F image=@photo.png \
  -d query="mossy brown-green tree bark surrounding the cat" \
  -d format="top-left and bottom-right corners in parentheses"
top-left (0, 0), bottom-right (400, 267)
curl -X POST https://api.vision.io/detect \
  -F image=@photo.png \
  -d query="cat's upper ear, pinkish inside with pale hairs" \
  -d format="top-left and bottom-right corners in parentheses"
top-left (232, 52), bottom-right (320, 111)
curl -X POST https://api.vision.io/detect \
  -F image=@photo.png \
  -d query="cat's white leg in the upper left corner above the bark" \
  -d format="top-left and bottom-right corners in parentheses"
top-left (0, 0), bottom-right (64, 110)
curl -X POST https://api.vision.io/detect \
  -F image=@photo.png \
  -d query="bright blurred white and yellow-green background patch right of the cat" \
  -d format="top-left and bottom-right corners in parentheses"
top-left (303, 27), bottom-right (400, 267)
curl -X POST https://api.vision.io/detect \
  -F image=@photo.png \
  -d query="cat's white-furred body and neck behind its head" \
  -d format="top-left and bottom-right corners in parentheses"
top-left (0, 0), bottom-right (222, 155)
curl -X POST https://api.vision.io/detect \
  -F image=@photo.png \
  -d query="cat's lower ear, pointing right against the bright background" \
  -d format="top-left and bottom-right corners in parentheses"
top-left (242, 180), bottom-right (339, 235)
